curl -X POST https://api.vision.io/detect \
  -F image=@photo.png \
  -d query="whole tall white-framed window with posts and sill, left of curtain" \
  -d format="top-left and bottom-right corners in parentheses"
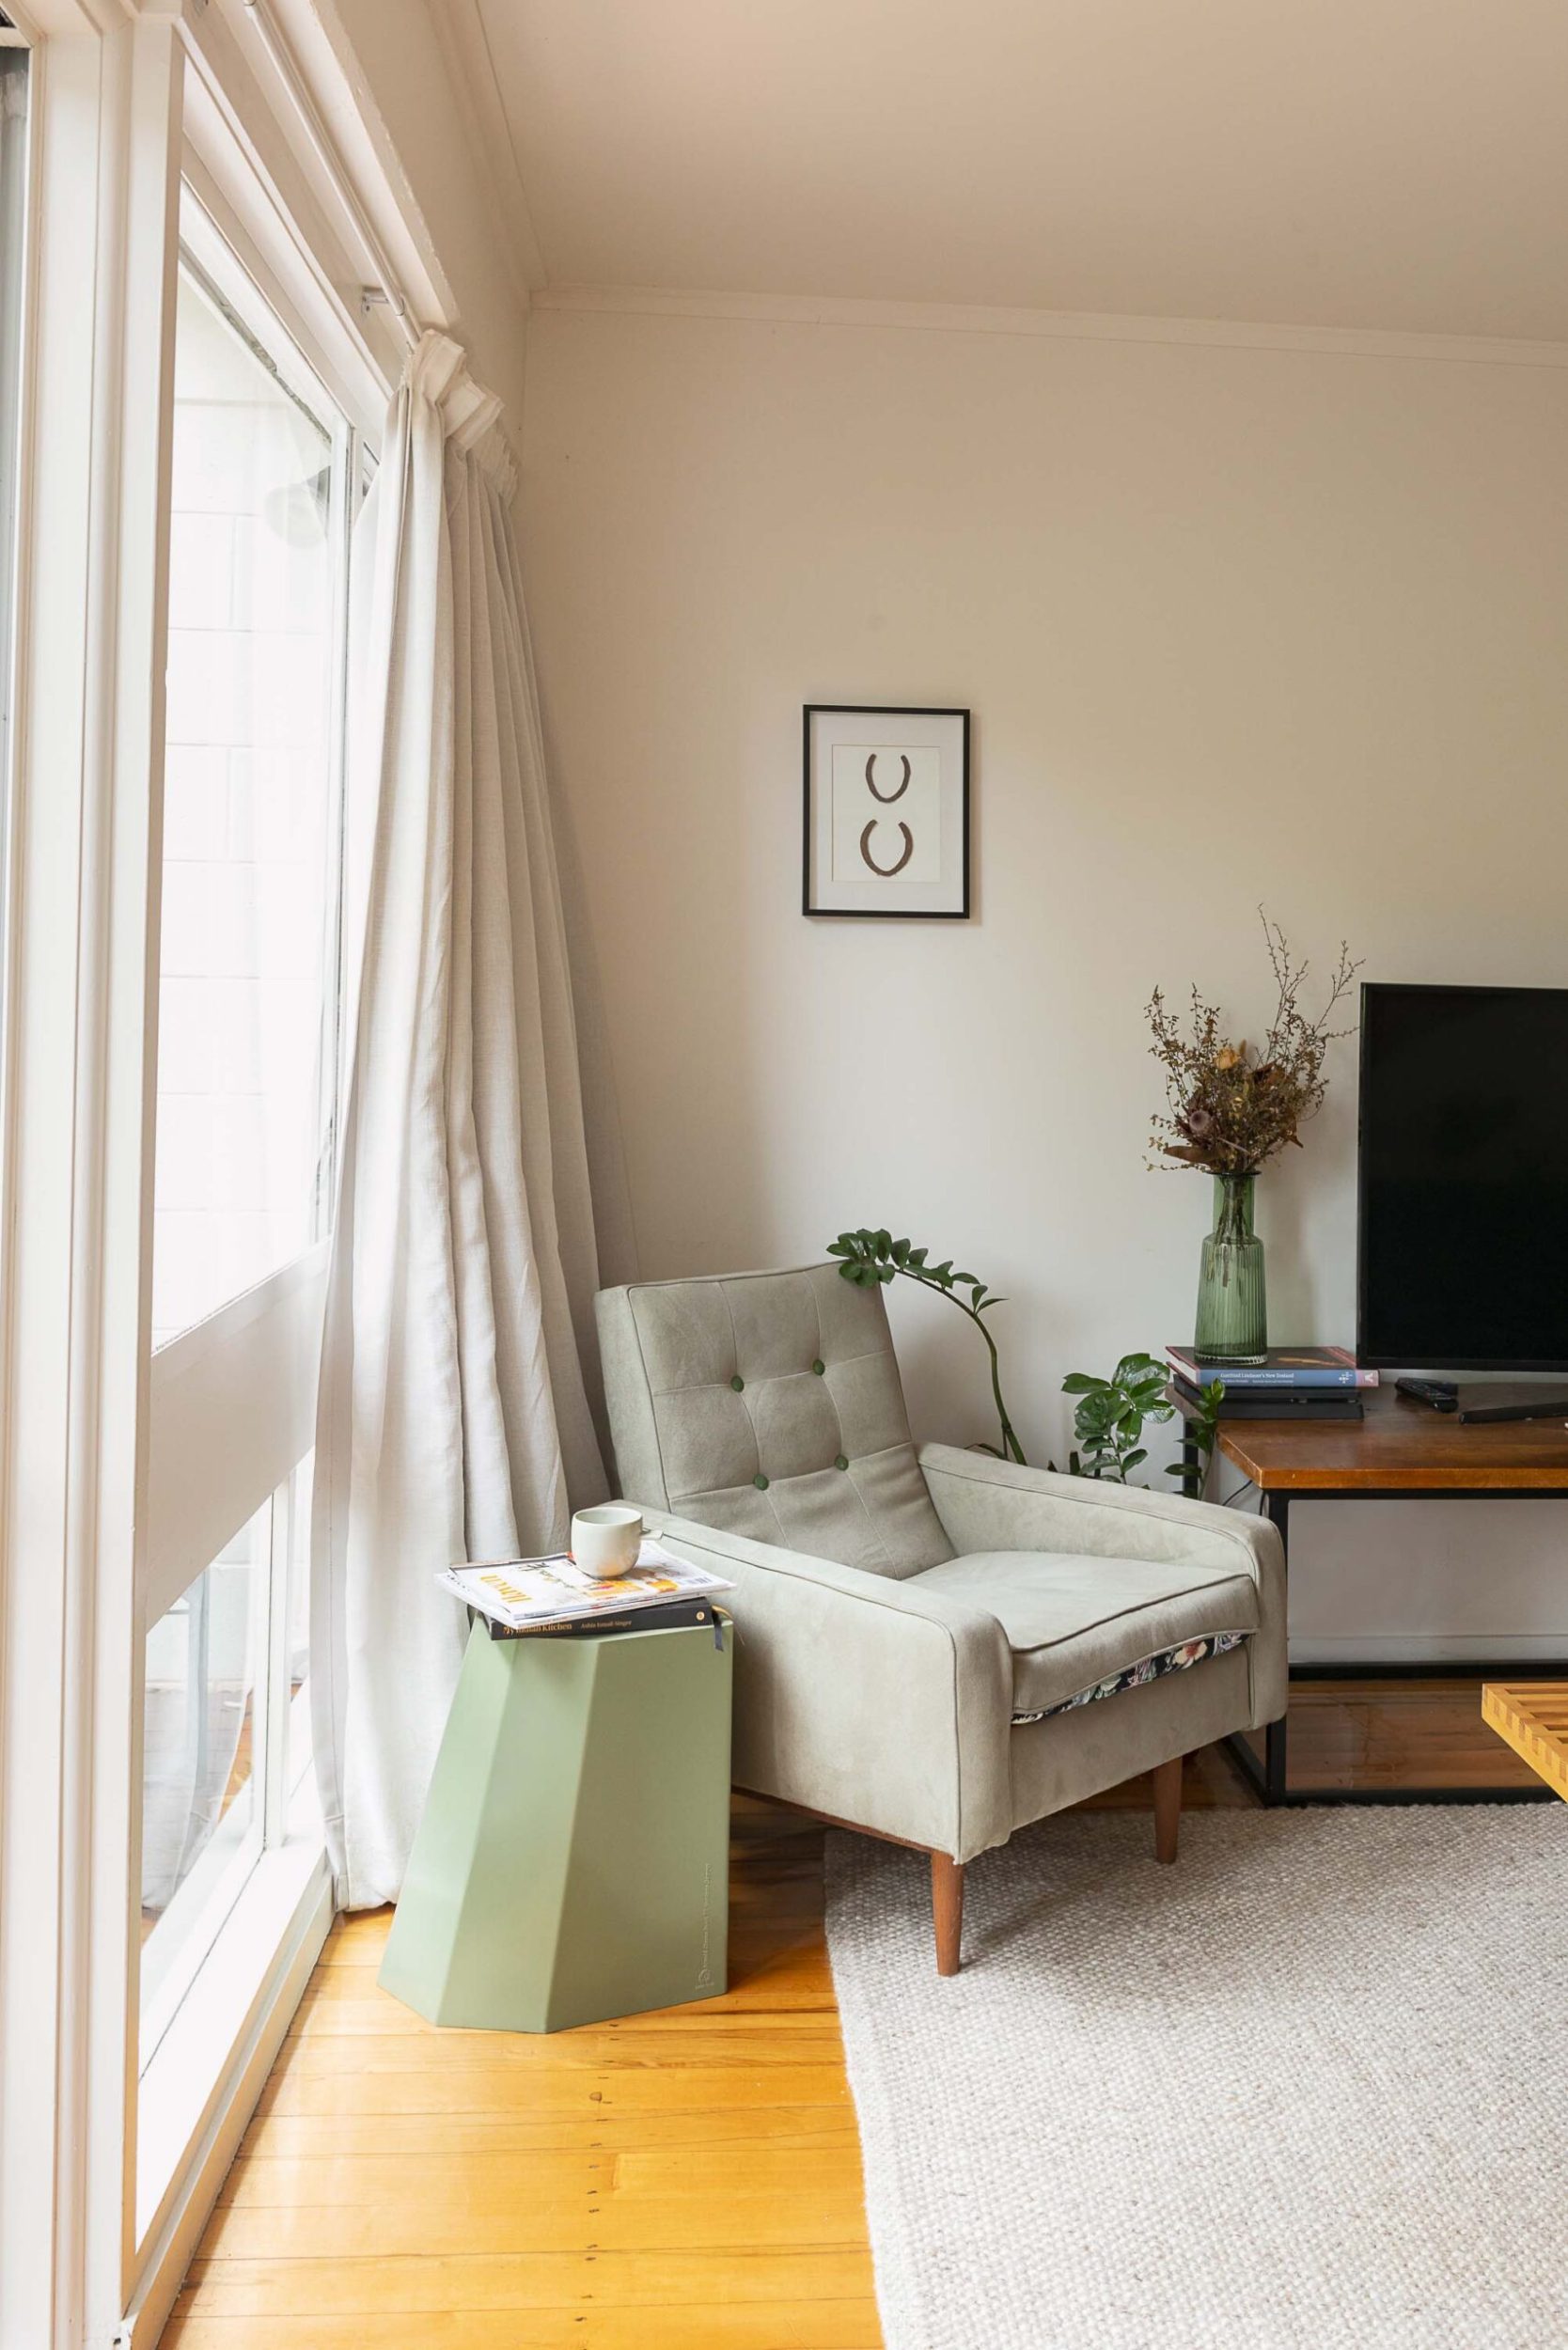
top-left (0, 18), bottom-right (395, 2350)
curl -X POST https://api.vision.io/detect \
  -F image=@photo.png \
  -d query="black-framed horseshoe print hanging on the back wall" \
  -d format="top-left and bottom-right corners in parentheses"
top-left (802, 703), bottom-right (968, 921)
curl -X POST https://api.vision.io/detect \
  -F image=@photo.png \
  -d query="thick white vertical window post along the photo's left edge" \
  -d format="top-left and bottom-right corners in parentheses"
top-left (0, 18), bottom-right (179, 2350)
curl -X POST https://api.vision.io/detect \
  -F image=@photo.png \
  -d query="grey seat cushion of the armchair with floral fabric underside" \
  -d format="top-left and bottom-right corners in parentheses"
top-left (915, 1551), bottom-right (1258, 1718)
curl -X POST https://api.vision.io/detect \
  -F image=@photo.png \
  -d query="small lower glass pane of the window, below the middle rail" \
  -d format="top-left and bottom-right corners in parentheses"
top-left (141, 1499), bottom-right (273, 2061)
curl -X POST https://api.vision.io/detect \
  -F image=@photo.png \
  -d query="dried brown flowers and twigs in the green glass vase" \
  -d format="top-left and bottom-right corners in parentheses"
top-left (1147, 907), bottom-right (1361, 1175)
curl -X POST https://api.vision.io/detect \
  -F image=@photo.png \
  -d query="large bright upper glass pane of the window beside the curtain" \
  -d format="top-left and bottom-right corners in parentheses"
top-left (153, 266), bottom-right (341, 1344)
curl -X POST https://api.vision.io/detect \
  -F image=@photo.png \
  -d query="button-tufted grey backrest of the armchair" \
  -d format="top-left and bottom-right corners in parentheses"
top-left (597, 1264), bottom-right (952, 1577)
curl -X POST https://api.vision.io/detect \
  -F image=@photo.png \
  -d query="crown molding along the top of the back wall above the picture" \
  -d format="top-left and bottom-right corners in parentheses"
top-left (534, 285), bottom-right (1568, 367)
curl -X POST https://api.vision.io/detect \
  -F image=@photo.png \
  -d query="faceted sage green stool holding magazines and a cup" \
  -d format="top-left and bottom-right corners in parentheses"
top-left (381, 1622), bottom-right (733, 2033)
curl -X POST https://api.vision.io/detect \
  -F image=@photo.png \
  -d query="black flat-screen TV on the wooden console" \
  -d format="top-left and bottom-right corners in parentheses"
top-left (1356, 987), bottom-right (1568, 1371)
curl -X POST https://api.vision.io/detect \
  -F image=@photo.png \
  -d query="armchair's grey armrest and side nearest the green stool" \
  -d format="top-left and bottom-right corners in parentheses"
top-left (644, 1509), bottom-right (1013, 1861)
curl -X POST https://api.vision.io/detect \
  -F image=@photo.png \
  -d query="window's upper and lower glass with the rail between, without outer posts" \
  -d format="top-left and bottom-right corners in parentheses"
top-left (136, 200), bottom-right (362, 2226)
